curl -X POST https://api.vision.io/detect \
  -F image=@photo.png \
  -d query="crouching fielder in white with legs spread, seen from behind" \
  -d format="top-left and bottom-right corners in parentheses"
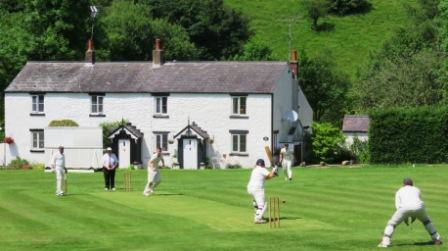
top-left (378, 178), bottom-right (442, 248)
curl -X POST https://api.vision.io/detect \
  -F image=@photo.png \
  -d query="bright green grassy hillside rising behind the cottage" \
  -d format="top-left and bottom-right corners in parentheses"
top-left (225, 0), bottom-right (416, 77)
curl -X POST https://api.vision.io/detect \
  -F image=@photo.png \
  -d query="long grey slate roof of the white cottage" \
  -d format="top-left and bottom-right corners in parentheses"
top-left (5, 61), bottom-right (288, 93)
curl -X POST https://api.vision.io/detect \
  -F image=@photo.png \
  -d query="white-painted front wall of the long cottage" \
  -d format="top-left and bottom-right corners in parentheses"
top-left (5, 93), bottom-right (271, 167)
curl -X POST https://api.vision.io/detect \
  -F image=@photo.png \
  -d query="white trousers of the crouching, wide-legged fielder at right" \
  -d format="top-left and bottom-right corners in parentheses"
top-left (382, 207), bottom-right (440, 245)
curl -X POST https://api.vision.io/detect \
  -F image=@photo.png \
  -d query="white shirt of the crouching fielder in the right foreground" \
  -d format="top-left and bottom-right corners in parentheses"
top-left (395, 186), bottom-right (424, 210)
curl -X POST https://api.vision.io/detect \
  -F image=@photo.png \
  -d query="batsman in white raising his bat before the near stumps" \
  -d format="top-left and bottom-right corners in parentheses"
top-left (247, 159), bottom-right (277, 224)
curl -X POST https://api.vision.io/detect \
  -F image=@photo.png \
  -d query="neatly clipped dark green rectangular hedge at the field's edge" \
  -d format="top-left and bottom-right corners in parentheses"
top-left (369, 107), bottom-right (448, 163)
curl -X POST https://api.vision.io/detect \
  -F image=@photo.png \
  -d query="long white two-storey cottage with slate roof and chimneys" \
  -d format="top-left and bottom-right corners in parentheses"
top-left (5, 39), bottom-right (313, 169)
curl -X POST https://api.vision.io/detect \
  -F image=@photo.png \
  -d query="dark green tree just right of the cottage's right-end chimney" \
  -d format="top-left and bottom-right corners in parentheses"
top-left (298, 53), bottom-right (350, 123)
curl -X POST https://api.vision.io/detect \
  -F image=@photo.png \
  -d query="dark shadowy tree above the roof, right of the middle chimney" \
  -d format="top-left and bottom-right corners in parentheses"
top-left (144, 0), bottom-right (251, 60)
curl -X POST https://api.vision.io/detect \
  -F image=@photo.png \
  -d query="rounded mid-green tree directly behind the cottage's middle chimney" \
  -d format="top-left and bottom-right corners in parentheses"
top-left (100, 1), bottom-right (198, 60)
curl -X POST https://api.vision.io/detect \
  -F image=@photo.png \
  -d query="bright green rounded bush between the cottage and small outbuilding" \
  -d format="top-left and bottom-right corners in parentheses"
top-left (311, 123), bottom-right (349, 163)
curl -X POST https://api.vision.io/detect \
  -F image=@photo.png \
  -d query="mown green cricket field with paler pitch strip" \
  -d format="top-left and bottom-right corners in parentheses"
top-left (0, 165), bottom-right (448, 251)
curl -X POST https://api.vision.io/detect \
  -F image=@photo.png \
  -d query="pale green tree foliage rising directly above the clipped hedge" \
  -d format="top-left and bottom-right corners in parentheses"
top-left (355, 0), bottom-right (444, 111)
